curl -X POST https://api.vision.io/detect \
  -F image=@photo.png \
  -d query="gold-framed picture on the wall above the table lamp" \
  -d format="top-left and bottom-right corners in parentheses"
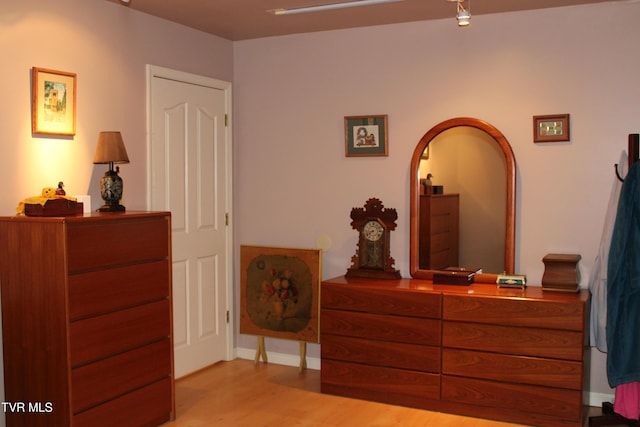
top-left (31, 67), bottom-right (76, 135)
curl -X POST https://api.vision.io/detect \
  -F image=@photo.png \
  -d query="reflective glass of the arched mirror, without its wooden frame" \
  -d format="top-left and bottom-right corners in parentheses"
top-left (419, 126), bottom-right (507, 272)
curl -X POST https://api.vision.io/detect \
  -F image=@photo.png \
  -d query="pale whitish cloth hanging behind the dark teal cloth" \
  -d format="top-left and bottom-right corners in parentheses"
top-left (589, 151), bottom-right (629, 353)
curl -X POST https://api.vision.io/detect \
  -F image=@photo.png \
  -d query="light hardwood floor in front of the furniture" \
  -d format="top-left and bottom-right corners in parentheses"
top-left (165, 359), bottom-right (536, 427)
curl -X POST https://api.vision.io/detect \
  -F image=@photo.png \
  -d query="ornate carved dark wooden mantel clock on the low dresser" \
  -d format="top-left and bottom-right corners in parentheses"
top-left (346, 198), bottom-right (400, 279)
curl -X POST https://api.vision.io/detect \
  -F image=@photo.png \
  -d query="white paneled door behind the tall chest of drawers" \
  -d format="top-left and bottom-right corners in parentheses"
top-left (149, 67), bottom-right (231, 378)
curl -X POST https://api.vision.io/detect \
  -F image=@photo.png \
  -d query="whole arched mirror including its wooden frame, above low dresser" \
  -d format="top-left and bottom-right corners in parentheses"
top-left (410, 117), bottom-right (516, 281)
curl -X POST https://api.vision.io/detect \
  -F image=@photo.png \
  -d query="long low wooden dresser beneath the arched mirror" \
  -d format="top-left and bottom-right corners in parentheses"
top-left (320, 277), bottom-right (589, 427)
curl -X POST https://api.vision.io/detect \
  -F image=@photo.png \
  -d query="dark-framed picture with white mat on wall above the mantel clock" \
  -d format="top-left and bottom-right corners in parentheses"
top-left (344, 115), bottom-right (389, 157)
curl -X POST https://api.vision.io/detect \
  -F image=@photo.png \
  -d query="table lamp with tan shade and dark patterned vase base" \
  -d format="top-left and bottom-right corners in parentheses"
top-left (93, 132), bottom-right (129, 212)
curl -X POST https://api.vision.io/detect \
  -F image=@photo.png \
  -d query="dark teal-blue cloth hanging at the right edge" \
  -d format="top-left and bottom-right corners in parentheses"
top-left (606, 162), bottom-right (640, 387)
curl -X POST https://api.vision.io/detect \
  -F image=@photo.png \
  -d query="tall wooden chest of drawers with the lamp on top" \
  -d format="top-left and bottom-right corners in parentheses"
top-left (0, 212), bottom-right (175, 427)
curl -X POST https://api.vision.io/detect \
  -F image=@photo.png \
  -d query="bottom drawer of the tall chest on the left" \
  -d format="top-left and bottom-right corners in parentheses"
top-left (72, 378), bottom-right (172, 427)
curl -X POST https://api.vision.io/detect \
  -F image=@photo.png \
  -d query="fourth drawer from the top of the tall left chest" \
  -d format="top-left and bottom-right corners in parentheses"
top-left (71, 338), bottom-right (171, 413)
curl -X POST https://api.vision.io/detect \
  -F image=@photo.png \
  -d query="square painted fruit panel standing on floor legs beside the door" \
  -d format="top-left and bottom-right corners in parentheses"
top-left (240, 245), bottom-right (322, 343)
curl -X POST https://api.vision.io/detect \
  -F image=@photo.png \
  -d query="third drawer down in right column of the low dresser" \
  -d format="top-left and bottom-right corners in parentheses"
top-left (442, 348), bottom-right (582, 390)
